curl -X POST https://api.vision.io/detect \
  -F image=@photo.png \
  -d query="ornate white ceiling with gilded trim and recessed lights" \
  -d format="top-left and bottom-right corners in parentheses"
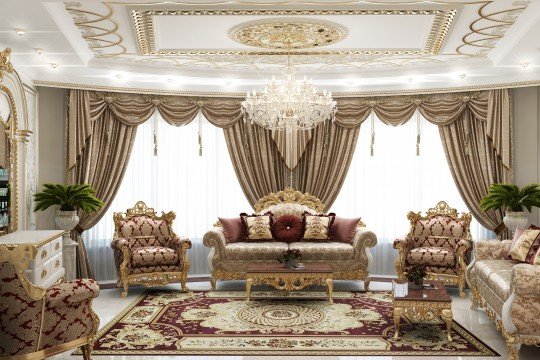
top-left (0, 0), bottom-right (540, 92)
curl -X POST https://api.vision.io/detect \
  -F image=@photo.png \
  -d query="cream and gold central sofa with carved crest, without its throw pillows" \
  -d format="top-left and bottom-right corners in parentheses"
top-left (203, 188), bottom-right (377, 290)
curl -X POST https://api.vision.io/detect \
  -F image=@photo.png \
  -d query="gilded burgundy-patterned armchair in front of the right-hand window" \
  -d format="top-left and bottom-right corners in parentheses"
top-left (394, 201), bottom-right (472, 297)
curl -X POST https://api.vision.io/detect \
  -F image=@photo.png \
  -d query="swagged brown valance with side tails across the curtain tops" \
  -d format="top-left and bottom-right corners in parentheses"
top-left (68, 89), bottom-right (511, 173)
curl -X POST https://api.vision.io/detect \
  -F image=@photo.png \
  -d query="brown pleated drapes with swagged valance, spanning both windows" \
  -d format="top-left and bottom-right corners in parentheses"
top-left (67, 89), bottom-right (512, 276)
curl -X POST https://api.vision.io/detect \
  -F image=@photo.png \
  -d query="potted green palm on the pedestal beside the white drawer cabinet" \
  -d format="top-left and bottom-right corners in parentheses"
top-left (34, 184), bottom-right (103, 230)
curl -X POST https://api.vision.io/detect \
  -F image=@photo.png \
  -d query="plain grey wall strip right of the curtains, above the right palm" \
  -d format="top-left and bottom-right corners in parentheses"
top-left (512, 87), bottom-right (540, 225)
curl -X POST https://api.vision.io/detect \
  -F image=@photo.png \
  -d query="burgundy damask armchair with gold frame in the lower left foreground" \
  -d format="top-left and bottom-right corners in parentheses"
top-left (0, 245), bottom-right (99, 360)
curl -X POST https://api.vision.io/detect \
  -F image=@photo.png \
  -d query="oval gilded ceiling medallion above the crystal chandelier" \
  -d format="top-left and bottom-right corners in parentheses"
top-left (229, 18), bottom-right (347, 50)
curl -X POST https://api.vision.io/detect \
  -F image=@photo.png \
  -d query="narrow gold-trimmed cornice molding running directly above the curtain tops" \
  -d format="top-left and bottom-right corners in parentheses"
top-left (33, 80), bottom-right (540, 99)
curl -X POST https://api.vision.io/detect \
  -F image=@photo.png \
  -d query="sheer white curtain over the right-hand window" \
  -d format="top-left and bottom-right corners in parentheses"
top-left (331, 113), bottom-right (493, 274)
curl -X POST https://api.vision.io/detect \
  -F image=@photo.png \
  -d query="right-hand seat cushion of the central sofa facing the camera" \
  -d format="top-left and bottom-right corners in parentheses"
top-left (290, 241), bottom-right (354, 260)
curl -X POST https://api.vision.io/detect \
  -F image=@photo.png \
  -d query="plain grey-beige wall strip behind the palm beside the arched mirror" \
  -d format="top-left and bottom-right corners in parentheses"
top-left (36, 87), bottom-right (66, 230)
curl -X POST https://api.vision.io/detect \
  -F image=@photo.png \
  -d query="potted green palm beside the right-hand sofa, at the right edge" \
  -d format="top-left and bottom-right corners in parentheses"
top-left (480, 184), bottom-right (540, 232)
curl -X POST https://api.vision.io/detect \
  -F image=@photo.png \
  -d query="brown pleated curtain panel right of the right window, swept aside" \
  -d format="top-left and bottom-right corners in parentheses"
top-left (439, 89), bottom-right (513, 230)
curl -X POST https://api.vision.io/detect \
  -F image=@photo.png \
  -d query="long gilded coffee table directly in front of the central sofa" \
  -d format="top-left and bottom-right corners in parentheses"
top-left (246, 262), bottom-right (334, 304)
